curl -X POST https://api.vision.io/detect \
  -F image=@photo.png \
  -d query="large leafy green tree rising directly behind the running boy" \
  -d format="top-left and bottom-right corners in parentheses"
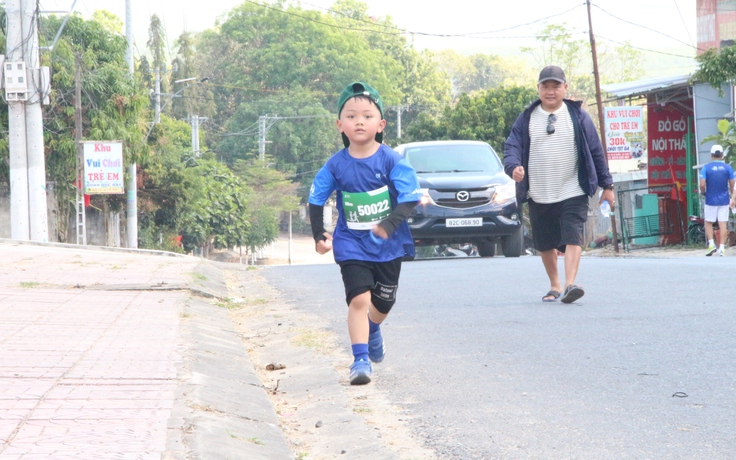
top-left (195, 1), bottom-right (449, 195)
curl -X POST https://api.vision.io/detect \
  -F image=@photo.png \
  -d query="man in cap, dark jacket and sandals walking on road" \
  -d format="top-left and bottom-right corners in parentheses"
top-left (503, 66), bottom-right (615, 303)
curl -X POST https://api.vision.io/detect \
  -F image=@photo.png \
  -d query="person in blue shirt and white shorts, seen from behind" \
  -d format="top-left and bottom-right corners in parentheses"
top-left (700, 145), bottom-right (734, 256)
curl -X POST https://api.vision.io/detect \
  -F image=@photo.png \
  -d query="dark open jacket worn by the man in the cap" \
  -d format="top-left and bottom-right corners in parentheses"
top-left (503, 99), bottom-right (613, 203)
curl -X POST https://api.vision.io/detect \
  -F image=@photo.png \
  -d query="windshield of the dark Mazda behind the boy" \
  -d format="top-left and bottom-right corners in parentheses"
top-left (405, 144), bottom-right (502, 174)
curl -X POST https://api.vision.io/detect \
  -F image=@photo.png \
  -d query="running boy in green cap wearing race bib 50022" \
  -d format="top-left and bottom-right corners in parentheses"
top-left (309, 82), bottom-right (421, 385)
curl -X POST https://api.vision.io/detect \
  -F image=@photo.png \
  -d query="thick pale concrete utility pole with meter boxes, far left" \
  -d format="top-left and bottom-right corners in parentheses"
top-left (5, 0), bottom-right (48, 242)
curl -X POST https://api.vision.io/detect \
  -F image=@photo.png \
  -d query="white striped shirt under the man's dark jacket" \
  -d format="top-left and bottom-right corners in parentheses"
top-left (528, 104), bottom-right (585, 204)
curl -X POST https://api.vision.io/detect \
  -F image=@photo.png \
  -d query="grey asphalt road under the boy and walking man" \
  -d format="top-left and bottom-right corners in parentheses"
top-left (262, 256), bottom-right (736, 459)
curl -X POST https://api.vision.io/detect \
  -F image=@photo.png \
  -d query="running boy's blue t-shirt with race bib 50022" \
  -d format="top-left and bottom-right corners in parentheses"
top-left (309, 144), bottom-right (422, 262)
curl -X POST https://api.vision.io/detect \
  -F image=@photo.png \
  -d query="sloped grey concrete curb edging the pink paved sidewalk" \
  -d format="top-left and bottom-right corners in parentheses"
top-left (162, 297), bottom-right (294, 460)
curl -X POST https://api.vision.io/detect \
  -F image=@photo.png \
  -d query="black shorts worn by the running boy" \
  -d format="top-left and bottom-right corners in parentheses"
top-left (340, 258), bottom-right (401, 314)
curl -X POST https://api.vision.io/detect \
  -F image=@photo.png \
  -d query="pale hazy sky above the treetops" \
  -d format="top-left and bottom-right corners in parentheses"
top-left (41, 0), bottom-right (697, 75)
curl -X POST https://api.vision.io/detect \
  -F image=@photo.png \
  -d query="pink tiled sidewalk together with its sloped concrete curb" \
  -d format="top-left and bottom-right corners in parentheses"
top-left (0, 240), bottom-right (293, 460)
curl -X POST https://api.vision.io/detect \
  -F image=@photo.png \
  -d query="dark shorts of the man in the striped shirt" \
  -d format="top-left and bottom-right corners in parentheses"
top-left (529, 195), bottom-right (588, 252)
